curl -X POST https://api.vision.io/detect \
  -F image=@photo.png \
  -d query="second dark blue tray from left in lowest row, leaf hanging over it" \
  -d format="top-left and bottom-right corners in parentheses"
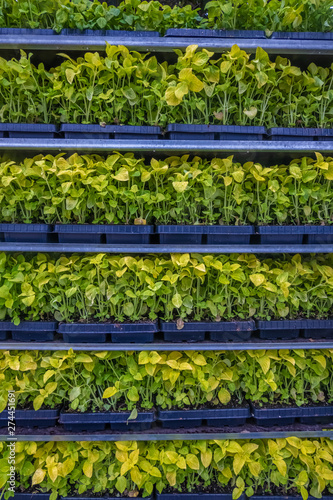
top-left (59, 411), bottom-right (155, 432)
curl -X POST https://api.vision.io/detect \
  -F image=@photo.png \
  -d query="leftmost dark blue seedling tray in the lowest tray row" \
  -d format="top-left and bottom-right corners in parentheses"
top-left (0, 410), bottom-right (59, 427)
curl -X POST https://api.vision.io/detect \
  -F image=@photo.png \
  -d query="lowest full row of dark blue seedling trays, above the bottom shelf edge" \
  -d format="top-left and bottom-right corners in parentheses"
top-left (0, 403), bottom-right (333, 432)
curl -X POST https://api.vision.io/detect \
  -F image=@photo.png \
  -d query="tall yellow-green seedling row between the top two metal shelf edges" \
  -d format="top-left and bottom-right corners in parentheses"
top-left (0, 44), bottom-right (333, 128)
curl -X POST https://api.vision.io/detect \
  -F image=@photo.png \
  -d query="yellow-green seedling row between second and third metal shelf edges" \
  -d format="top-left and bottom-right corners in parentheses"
top-left (0, 153), bottom-right (333, 225)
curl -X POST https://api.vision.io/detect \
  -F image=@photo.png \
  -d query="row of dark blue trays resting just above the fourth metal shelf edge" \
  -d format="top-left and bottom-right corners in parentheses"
top-left (0, 319), bottom-right (333, 343)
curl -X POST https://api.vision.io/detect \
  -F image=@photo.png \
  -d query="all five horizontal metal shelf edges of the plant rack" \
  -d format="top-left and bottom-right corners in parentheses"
top-left (0, 35), bottom-right (333, 441)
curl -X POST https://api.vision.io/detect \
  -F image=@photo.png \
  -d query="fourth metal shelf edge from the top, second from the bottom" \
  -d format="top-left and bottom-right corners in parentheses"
top-left (0, 339), bottom-right (333, 351)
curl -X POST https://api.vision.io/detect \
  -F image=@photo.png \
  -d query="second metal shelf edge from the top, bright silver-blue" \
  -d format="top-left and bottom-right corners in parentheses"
top-left (0, 138), bottom-right (333, 154)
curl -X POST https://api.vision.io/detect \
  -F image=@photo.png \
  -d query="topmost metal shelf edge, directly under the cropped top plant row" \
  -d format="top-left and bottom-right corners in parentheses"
top-left (0, 34), bottom-right (333, 56)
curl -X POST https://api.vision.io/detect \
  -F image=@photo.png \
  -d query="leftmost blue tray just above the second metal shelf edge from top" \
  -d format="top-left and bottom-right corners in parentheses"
top-left (0, 123), bottom-right (57, 139)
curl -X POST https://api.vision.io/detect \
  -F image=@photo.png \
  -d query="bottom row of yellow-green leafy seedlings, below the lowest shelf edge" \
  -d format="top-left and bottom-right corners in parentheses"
top-left (0, 437), bottom-right (333, 500)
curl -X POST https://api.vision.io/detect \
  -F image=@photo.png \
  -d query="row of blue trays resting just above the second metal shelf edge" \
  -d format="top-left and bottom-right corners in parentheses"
top-left (0, 123), bottom-right (333, 141)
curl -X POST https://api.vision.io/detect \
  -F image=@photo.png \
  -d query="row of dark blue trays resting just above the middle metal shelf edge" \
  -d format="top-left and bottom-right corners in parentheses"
top-left (0, 223), bottom-right (333, 245)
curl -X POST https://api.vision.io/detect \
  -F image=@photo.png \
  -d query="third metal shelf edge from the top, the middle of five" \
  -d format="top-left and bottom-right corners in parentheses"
top-left (0, 242), bottom-right (333, 255)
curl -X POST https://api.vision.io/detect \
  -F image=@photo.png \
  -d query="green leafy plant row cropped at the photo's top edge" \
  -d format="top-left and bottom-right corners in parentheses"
top-left (0, 0), bottom-right (333, 36)
